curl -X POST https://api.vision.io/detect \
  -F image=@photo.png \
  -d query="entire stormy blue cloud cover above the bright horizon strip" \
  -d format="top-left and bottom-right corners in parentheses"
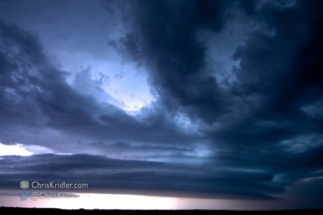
top-left (0, 0), bottom-right (323, 208)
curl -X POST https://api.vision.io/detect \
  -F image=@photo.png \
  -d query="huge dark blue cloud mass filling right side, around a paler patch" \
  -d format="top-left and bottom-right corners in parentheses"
top-left (100, 1), bottom-right (323, 203)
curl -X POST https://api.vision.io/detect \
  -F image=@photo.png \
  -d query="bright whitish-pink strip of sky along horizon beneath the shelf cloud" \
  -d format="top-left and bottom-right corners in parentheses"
top-left (0, 193), bottom-right (263, 210)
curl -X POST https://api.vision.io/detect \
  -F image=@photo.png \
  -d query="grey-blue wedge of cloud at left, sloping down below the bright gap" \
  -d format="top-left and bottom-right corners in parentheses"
top-left (0, 18), bottom-right (201, 153)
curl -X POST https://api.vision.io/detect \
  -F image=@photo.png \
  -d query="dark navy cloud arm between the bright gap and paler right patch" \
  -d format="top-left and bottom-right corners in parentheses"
top-left (107, 1), bottom-right (239, 122)
